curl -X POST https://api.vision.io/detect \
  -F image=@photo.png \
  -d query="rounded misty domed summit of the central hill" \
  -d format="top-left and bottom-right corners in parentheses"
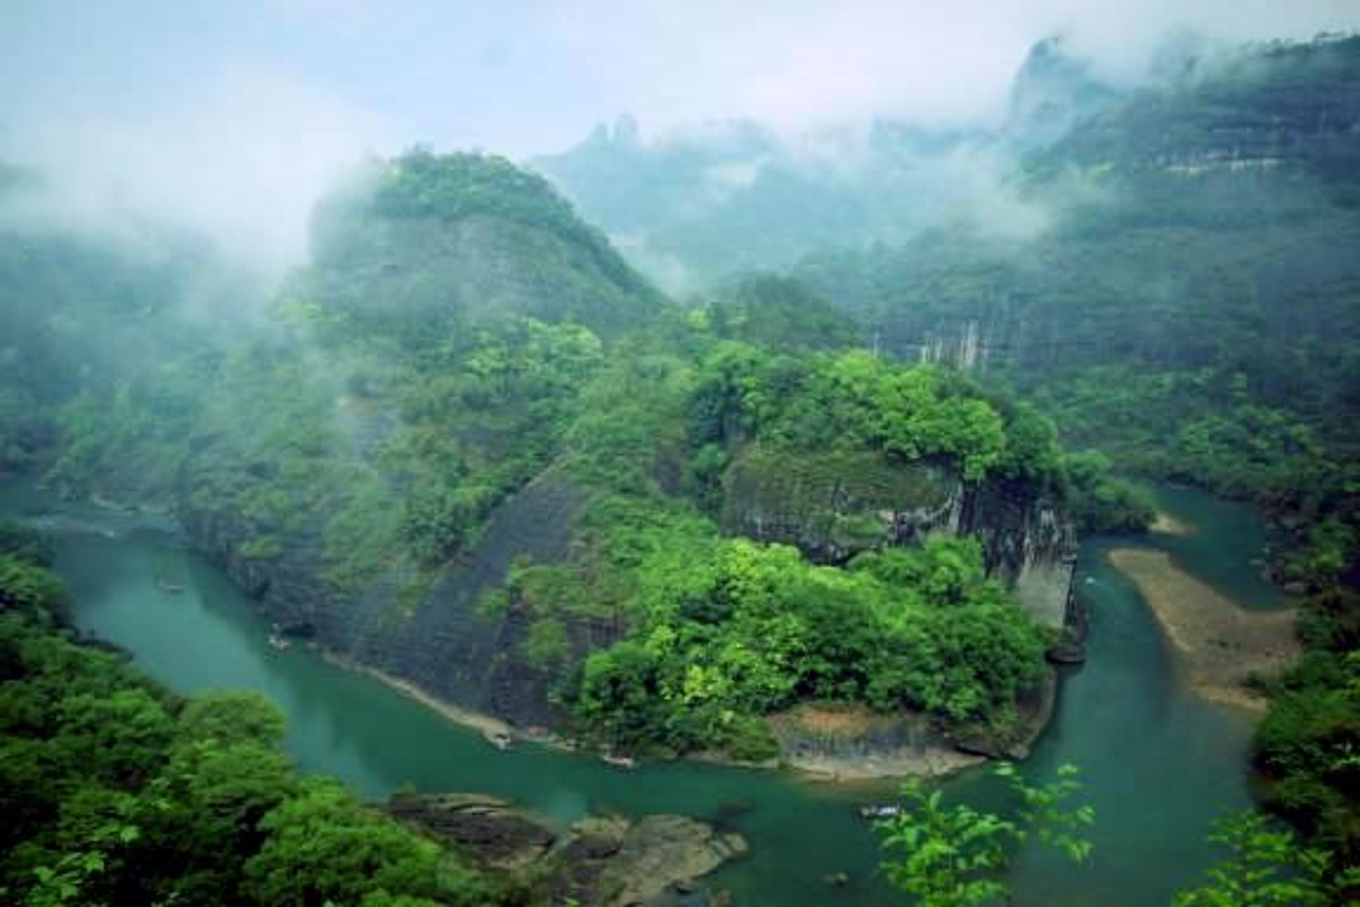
top-left (291, 148), bottom-right (660, 339)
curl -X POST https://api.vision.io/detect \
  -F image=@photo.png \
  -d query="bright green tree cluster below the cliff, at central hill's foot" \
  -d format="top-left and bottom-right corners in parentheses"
top-left (560, 534), bottom-right (1043, 759)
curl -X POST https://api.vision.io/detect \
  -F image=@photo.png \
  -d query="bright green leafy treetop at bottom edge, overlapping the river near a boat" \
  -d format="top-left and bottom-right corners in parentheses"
top-left (877, 764), bottom-right (1095, 907)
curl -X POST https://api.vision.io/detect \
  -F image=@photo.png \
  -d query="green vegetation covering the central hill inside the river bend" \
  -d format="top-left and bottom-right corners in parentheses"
top-left (0, 150), bottom-right (1093, 757)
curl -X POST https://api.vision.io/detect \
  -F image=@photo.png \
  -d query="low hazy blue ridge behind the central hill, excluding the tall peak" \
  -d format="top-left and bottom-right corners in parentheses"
top-left (530, 121), bottom-right (996, 291)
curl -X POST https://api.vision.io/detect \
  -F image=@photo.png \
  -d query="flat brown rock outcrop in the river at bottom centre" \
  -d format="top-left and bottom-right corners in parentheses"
top-left (386, 794), bottom-right (747, 907)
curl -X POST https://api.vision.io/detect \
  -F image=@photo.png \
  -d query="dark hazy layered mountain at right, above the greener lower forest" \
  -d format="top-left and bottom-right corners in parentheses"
top-left (793, 38), bottom-right (1360, 481)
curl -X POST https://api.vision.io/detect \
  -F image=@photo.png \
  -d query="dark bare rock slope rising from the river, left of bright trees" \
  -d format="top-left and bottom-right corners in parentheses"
top-left (178, 472), bottom-right (585, 726)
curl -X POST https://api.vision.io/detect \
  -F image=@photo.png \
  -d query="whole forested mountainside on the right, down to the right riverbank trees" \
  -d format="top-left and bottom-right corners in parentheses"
top-left (796, 38), bottom-right (1360, 903)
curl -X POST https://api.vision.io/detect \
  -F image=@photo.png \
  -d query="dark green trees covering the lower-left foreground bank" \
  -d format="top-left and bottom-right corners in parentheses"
top-left (0, 528), bottom-right (511, 907)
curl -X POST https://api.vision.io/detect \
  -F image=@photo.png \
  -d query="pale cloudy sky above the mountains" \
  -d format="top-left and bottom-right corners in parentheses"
top-left (0, 0), bottom-right (1360, 266)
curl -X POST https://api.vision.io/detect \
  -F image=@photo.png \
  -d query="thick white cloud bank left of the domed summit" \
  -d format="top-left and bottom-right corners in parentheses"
top-left (3, 67), bottom-right (386, 277)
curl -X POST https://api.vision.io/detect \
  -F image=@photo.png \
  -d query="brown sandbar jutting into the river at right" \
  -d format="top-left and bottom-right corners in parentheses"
top-left (1108, 548), bottom-right (1299, 710)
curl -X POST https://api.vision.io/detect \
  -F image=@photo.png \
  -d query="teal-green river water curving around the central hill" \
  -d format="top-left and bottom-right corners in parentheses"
top-left (0, 483), bottom-right (1280, 907)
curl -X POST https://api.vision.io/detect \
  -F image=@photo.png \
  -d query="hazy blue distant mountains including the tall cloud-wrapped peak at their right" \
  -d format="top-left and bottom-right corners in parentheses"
top-left (530, 38), bottom-right (1123, 291)
